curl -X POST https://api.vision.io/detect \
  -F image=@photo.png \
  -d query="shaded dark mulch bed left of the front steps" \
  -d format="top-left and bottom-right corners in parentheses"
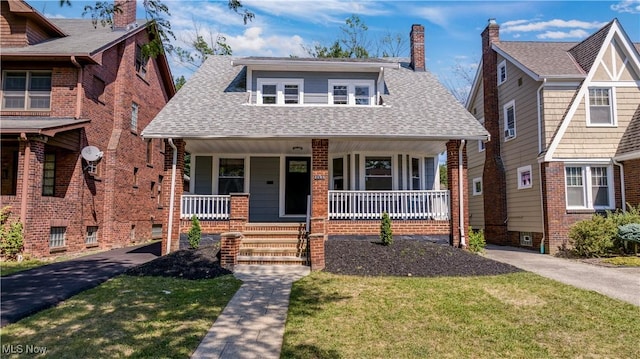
top-left (126, 243), bottom-right (231, 279)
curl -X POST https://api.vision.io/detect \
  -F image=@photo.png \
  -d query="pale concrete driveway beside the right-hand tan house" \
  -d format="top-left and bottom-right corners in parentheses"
top-left (486, 245), bottom-right (640, 306)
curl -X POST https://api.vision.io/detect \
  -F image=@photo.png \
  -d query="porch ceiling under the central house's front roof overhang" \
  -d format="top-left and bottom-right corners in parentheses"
top-left (186, 139), bottom-right (446, 155)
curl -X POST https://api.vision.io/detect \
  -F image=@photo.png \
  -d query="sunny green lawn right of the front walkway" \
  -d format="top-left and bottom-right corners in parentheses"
top-left (282, 272), bottom-right (640, 358)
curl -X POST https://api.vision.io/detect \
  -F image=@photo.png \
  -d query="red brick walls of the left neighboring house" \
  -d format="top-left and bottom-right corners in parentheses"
top-left (2, 27), bottom-right (172, 256)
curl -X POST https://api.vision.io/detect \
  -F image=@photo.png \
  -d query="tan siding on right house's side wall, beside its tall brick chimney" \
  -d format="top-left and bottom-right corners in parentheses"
top-left (498, 54), bottom-right (542, 232)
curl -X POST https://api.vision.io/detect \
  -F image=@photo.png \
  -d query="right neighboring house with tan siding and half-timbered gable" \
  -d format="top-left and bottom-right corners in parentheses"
top-left (467, 20), bottom-right (640, 253)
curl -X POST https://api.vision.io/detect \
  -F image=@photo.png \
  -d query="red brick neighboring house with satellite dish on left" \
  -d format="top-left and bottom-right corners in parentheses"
top-left (0, 0), bottom-right (175, 257)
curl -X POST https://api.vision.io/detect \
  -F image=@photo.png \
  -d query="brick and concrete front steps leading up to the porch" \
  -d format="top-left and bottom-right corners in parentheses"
top-left (238, 223), bottom-right (308, 265)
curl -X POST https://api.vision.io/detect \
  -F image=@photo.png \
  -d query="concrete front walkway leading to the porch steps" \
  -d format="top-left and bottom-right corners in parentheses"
top-left (191, 265), bottom-right (309, 359)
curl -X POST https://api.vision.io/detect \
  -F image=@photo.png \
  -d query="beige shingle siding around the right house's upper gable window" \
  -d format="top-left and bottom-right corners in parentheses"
top-left (554, 87), bottom-right (640, 158)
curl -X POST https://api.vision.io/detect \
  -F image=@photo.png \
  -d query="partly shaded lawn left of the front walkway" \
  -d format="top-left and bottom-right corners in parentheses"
top-left (0, 275), bottom-right (241, 358)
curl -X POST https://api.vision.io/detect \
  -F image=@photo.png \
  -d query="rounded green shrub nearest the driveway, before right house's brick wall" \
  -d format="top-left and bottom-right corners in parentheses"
top-left (569, 214), bottom-right (618, 257)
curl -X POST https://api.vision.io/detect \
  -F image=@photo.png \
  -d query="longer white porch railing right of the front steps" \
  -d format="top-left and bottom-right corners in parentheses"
top-left (329, 191), bottom-right (449, 220)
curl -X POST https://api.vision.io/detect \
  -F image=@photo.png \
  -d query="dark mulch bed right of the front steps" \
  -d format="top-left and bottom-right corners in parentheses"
top-left (325, 239), bottom-right (522, 277)
